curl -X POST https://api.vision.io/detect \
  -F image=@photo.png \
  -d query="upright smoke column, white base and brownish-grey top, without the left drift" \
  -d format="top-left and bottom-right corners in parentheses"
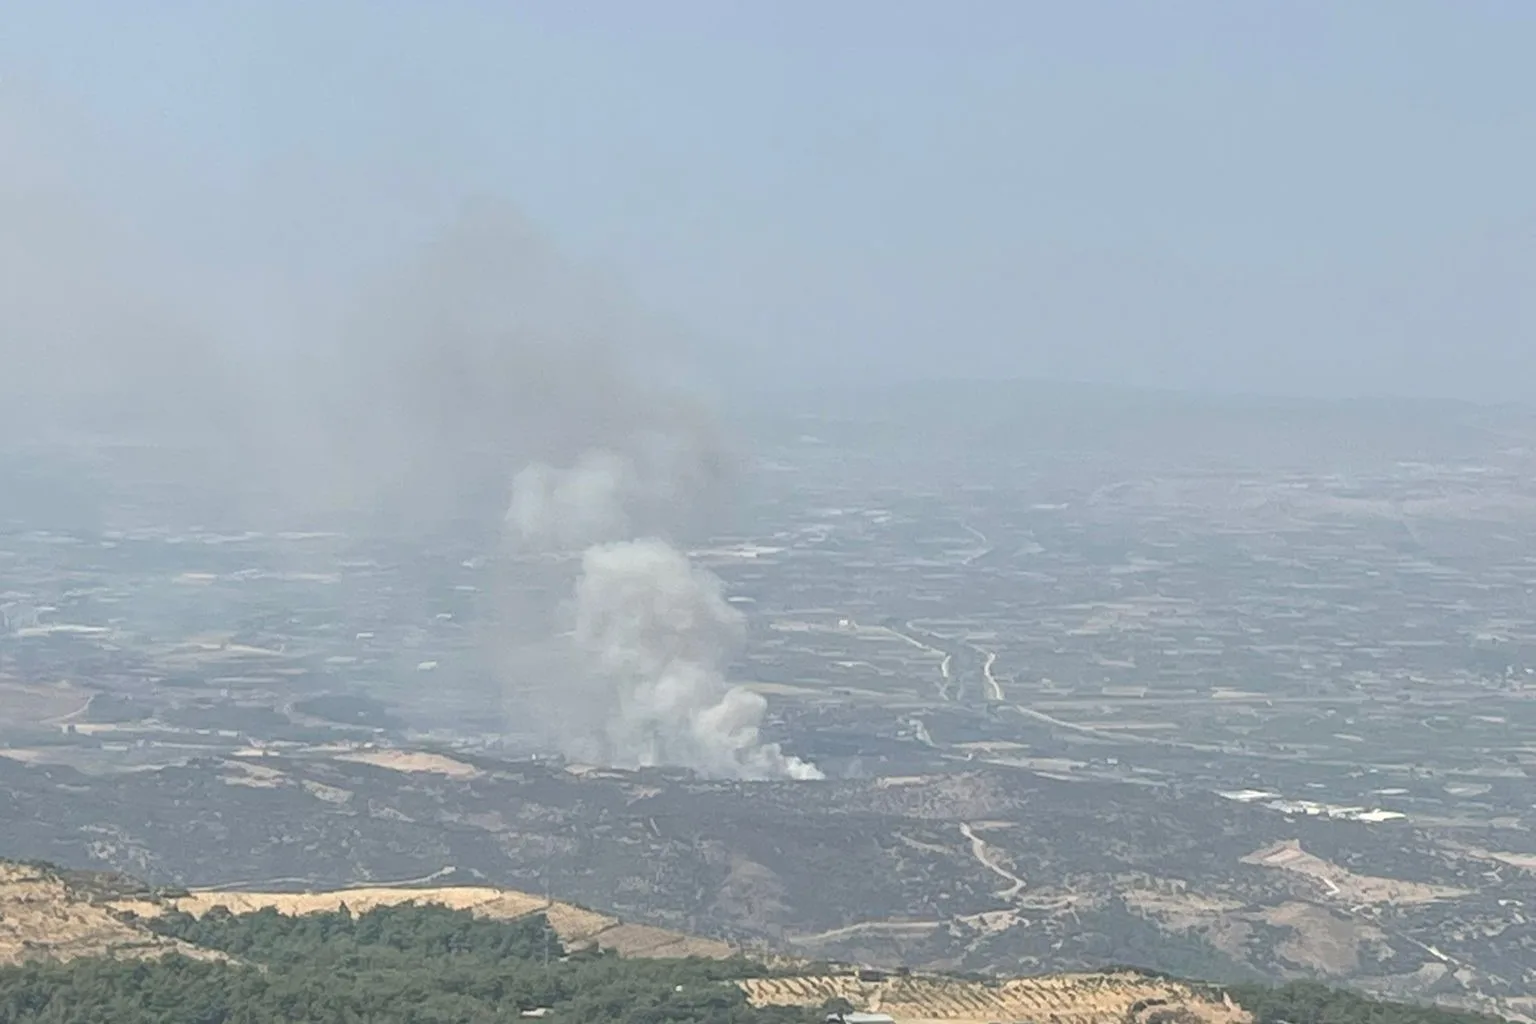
top-left (323, 206), bottom-right (814, 778)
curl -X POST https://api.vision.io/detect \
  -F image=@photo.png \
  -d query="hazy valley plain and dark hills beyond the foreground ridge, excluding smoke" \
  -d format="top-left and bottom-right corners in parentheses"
top-left (0, 385), bottom-right (1536, 1015)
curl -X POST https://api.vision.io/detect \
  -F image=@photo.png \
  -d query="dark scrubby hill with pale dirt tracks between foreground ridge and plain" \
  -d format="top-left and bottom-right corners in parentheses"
top-left (0, 745), bottom-right (1536, 1016)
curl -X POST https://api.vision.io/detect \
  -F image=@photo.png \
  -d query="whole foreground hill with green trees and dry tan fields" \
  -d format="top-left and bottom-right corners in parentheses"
top-left (0, 861), bottom-right (1517, 1024)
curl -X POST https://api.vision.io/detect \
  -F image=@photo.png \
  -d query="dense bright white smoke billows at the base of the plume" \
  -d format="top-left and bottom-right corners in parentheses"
top-left (507, 451), bottom-right (822, 778)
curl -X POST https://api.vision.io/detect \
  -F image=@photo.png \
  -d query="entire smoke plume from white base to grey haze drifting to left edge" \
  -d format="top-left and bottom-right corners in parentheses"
top-left (0, 94), bottom-right (814, 778)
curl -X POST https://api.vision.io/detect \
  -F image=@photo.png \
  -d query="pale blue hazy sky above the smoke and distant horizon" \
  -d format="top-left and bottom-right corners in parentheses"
top-left (0, 0), bottom-right (1536, 399)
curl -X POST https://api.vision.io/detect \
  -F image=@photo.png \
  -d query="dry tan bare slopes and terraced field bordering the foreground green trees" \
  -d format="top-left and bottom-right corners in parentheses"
top-left (0, 863), bottom-right (1253, 1024)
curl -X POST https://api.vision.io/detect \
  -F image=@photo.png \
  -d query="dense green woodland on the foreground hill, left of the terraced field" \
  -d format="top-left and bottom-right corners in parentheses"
top-left (0, 906), bottom-right (820, 1024)
